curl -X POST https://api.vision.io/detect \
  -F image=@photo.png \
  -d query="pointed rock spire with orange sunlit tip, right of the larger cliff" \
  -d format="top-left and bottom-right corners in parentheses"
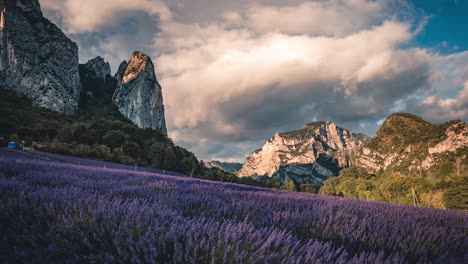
top-left (112, 51), bottom-right (167, 135)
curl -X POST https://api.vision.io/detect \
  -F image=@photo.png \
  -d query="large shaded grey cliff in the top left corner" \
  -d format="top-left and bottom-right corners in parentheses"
top-left (0, 0), bottom-right (80, 113)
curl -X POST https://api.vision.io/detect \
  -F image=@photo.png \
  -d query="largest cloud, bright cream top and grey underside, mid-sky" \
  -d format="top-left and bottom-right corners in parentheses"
top-left (158, 21), bottom-right (428, 148)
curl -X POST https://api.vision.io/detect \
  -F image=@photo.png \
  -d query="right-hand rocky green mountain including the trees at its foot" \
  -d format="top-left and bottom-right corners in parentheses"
top-left (320, 113), bottom-right (468, 210)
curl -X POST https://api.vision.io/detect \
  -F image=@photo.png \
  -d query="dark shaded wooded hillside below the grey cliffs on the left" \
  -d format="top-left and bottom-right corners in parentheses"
top-left (0, 67), bottom-right (240, 184)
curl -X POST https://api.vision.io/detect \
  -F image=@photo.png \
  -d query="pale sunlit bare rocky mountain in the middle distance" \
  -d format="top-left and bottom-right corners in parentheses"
top-left (238, 122), bottom-right (370, 178)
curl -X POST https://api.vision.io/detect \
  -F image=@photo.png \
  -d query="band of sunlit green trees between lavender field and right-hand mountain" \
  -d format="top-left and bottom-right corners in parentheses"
top-left (319, 166), bottom-right (468, 210)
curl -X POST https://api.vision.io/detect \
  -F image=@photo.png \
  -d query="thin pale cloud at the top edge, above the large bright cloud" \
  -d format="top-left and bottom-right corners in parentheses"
top-left (236, 0), bottom-right (386, 36)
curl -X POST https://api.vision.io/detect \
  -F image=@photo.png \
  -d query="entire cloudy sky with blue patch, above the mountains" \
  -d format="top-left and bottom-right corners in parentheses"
top-left (40, 0), bottom-right (468, 162)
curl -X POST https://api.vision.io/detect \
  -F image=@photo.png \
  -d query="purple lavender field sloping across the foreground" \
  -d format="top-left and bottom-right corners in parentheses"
top-left (0, 153), bottom-right (468, 263)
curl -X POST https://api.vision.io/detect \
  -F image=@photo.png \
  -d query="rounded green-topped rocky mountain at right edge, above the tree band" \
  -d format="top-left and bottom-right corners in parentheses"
top-left (357, 113), bottom-right (468, 176)
